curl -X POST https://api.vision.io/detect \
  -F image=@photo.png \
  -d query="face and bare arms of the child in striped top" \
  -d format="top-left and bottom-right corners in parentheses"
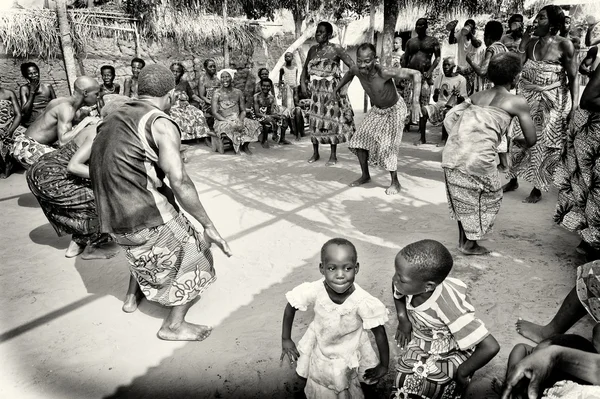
top-left (393, 253), bottom-right (500, 390)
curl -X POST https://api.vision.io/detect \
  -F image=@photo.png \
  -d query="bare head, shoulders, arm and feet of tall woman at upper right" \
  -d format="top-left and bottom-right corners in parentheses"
top-left (503, 10), bottom-right (579, 204)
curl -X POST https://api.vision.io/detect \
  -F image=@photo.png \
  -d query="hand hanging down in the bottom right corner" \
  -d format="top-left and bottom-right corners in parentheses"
top-left (502, 346), bottom-right (556, 399)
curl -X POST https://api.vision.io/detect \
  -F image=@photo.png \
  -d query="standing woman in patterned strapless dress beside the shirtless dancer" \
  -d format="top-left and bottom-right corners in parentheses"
top-left (300, 22), bottom-right (354, 165)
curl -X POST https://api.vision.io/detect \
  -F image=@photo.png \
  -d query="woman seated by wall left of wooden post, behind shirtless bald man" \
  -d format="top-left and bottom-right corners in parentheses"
top-left (19, 62), bottom-right (56, 128)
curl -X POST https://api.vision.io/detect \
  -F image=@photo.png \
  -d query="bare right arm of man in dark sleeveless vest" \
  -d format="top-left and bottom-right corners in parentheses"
top-left (152, 118), bottom-right (231, 256)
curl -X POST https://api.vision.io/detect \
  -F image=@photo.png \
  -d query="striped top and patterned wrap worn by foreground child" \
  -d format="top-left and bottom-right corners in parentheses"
top-left (392, 277), bottom-right (489, 399)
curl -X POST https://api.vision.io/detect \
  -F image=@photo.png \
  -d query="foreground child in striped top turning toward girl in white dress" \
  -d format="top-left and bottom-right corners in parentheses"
top-left (392, 240), bottom-right (500, 399)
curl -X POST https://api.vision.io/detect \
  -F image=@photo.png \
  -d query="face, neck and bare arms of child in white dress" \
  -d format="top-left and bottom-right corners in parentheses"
top-left (280, 245), bottom-right (390, 382)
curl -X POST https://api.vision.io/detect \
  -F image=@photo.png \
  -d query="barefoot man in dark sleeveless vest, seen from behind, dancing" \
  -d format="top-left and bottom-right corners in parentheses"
top-left (90, 64), bottom-right (231, 341)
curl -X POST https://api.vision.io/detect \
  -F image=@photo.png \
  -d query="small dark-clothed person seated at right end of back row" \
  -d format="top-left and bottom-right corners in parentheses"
top-left (254, 78), bottom-right (291, 148)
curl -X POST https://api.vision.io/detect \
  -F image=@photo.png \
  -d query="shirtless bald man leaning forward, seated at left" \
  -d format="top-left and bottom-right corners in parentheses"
top-left (12, 76), bottom-right (100, 169)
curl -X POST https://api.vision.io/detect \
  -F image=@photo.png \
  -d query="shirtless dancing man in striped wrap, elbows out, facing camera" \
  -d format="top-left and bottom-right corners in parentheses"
top-left (335, 43), bottom-right (421, 195)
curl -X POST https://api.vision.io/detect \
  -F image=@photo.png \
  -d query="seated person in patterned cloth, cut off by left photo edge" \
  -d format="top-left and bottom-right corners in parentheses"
top-left (0, 87), bottom-right (25, 179)
